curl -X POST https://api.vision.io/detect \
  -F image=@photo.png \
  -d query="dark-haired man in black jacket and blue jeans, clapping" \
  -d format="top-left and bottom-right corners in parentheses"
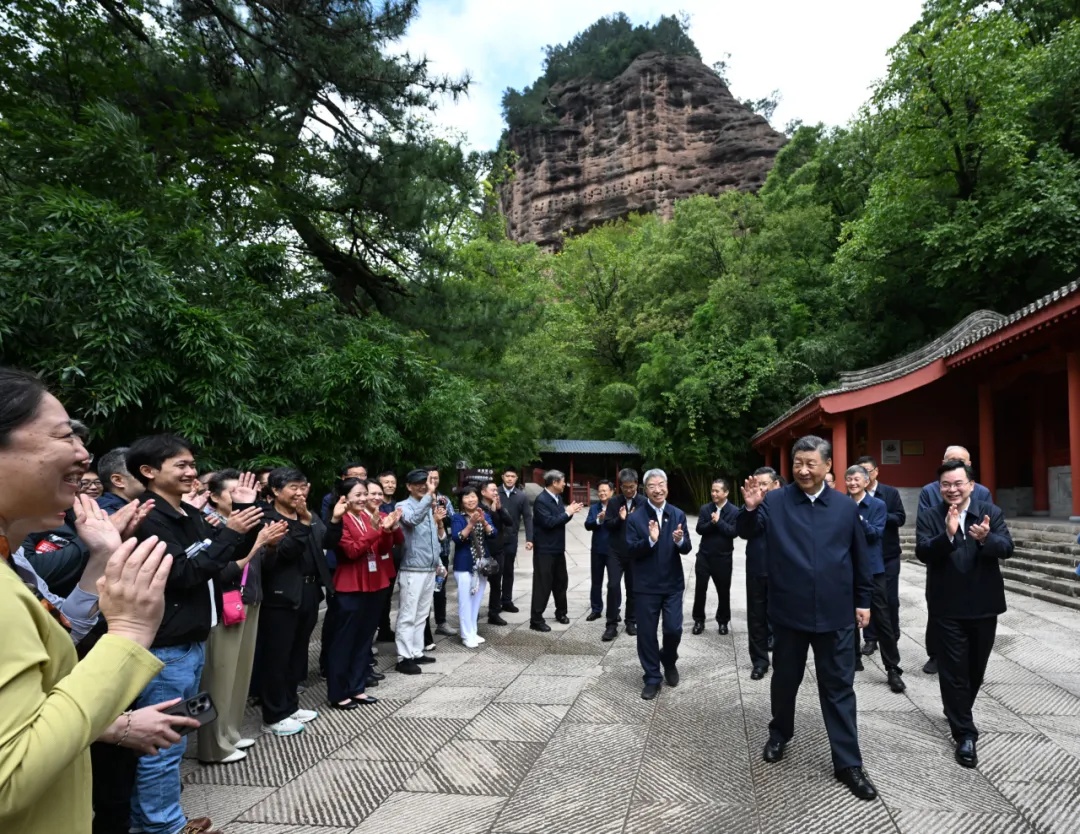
top-left (126, 434), bottom-right (262, 834)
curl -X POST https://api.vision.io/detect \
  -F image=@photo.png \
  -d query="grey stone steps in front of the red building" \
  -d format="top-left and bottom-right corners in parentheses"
top-left (900, 519), bottom-right (1080, 610)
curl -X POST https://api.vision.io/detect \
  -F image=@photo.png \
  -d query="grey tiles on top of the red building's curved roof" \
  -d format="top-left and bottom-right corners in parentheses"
top-left (751, 281), bottom-right (1080, 443)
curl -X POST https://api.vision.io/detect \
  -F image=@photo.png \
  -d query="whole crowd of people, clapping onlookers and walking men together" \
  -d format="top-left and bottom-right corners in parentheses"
top-left (0, 368), bottom-right (1012, 834)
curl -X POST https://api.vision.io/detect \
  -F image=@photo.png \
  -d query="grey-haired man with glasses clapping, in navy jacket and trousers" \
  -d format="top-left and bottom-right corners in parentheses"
top-left (626, 469), bottom-right (691, 701)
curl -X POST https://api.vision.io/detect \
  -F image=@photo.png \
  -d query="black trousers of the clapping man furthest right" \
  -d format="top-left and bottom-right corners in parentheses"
top-left (935, 617), bottom-right (998, 741)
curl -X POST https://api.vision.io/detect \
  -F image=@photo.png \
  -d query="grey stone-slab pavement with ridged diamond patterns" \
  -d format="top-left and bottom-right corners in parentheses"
top-left (184, 519), bottom-right (1080, 834)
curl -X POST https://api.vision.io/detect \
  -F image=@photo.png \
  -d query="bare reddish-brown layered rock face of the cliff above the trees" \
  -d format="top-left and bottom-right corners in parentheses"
top-left (499, 52), bottom-right (785, 248)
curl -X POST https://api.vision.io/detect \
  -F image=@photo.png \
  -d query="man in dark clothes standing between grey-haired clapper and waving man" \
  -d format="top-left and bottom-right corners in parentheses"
top-left (693, 477), bottom-right (739, 634)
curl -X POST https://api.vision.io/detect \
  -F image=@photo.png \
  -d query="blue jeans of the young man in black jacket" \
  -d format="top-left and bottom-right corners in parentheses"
top-left (131, 643), bottom-right (206, 834)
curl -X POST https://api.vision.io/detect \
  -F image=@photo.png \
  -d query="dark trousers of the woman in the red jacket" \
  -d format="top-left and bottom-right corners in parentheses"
top-left (326, 591), bottom-right (387, 703)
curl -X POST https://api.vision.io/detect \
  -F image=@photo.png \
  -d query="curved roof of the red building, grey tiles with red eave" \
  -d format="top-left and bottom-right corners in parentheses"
top-left (751, 281), bottom-right (1080, 445)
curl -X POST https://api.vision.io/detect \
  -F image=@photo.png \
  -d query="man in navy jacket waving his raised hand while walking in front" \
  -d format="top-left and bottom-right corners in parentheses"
top-left (735, 435), bottom-right (877, 799)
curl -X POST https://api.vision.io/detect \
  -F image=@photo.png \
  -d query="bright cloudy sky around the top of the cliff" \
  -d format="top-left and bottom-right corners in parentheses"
top-left (401, 0), bottom-right (922, 150)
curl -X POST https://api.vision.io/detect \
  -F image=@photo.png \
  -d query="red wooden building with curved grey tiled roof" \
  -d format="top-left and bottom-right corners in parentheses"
top-left (751, 281), bottom-right (1080, 521)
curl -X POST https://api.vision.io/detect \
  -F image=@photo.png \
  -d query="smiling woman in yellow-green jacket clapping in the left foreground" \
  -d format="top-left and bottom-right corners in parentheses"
top-left (0, 368), bottom-right (179, 834)
